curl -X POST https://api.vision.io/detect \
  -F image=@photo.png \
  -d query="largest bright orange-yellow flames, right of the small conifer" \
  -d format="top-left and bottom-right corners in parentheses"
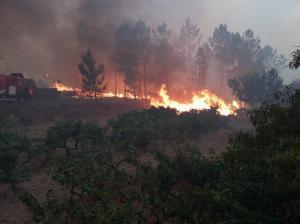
top-left (151, 85), bottom-right (240, 116)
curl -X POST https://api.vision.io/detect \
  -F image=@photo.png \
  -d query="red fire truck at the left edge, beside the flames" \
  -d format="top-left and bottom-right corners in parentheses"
top-left (0, 73), bottom-right (35, 101)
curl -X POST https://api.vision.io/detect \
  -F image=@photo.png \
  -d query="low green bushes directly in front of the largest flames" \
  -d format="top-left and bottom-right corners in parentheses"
top-left (110, 108), bottom-right (227, 149)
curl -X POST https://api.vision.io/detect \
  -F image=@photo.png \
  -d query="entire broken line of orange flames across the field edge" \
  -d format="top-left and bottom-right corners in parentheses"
top-left (53, 82), bottom-right (241, 116)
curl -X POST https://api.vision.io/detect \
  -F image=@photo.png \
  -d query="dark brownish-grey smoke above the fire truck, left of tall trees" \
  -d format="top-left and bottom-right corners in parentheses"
top-left (0, 0), bottom-right (144, 85)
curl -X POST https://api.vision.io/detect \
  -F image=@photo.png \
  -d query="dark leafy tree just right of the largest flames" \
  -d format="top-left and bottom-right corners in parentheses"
top-left (228, 69), bottom-right (283, 106)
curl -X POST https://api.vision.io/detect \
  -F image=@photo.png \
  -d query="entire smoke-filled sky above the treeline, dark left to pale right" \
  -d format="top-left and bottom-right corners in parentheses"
top-left (0, 0), bottom-right (300, 86)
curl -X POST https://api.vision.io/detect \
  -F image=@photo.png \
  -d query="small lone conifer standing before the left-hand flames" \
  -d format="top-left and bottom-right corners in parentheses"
top-left (78, 49), bottom-right (106, 99)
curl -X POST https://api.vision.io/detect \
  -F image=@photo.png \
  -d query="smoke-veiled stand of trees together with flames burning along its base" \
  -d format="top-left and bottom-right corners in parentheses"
top-left (44, 18), bottom-right (285, 116)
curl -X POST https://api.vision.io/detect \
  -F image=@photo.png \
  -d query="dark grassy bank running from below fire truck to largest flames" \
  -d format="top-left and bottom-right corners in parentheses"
top-left (0, 98), bottom-right (149, 127)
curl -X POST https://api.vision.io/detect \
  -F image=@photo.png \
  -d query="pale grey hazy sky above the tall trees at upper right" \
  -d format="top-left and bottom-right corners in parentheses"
top-left (140, 0), bottom-right (300, 80)
